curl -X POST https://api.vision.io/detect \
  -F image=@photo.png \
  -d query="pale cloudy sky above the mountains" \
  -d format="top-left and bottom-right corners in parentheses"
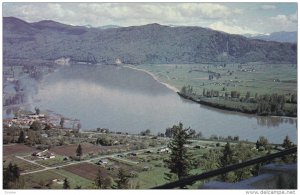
top-left (2, 3), bottom-right (298, 34)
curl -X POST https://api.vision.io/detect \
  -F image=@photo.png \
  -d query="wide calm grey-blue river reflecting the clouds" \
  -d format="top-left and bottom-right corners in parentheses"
top-left (34, 65), bottom-right (297, 143)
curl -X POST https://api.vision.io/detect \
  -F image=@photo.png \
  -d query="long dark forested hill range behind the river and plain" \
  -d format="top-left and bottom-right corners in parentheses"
top-left (3, 17), bottom-right (297, 64)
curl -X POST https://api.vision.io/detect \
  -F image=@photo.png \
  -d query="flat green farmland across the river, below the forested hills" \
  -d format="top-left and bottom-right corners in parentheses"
top-left (138, 63), bottom-right (297, 97)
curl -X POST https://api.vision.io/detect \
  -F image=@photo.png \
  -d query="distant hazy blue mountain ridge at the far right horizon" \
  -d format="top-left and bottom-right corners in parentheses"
top-left (246, 31), bottom-right (297, 43)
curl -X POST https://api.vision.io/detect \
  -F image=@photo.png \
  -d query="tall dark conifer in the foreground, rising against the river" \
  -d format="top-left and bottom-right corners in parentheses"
top-left (164, 123), bottom-right (192, 184)
